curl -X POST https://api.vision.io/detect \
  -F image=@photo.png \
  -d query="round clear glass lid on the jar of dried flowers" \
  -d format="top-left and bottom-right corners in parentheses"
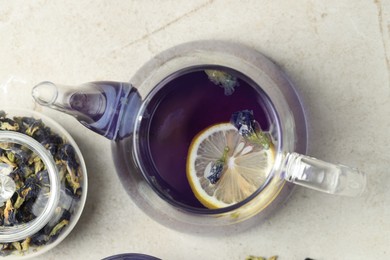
top-left (0, 131), bottom-right (60, 243)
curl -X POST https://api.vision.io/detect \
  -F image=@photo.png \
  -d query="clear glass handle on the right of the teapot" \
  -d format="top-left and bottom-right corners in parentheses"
top-left (282, 153), bottom-right (366, 197)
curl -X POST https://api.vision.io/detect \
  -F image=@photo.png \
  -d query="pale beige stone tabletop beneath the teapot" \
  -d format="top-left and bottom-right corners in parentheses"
top-left (0, 0), bottom-right (390, 260)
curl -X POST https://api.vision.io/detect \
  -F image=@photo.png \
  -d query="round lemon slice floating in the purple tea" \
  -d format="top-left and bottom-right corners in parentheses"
top-left (186, 123), bottom-right (275, 209)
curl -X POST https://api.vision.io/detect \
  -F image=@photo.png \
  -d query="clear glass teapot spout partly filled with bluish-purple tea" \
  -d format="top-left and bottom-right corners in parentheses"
top-left (32, 81), bottom-right (141, 140)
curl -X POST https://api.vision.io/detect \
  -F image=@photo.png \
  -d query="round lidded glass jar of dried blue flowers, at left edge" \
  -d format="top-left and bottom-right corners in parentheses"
top-left (0, 107), bottom-right (87, 259)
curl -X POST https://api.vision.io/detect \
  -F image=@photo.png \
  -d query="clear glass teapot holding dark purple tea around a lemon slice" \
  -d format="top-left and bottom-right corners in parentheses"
top-left (32, 41), bottom-right (365, 226)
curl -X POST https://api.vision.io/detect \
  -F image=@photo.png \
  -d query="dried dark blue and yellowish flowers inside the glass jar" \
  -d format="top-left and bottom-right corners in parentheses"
top-left (0, 111), bottom-right (83, 256)
